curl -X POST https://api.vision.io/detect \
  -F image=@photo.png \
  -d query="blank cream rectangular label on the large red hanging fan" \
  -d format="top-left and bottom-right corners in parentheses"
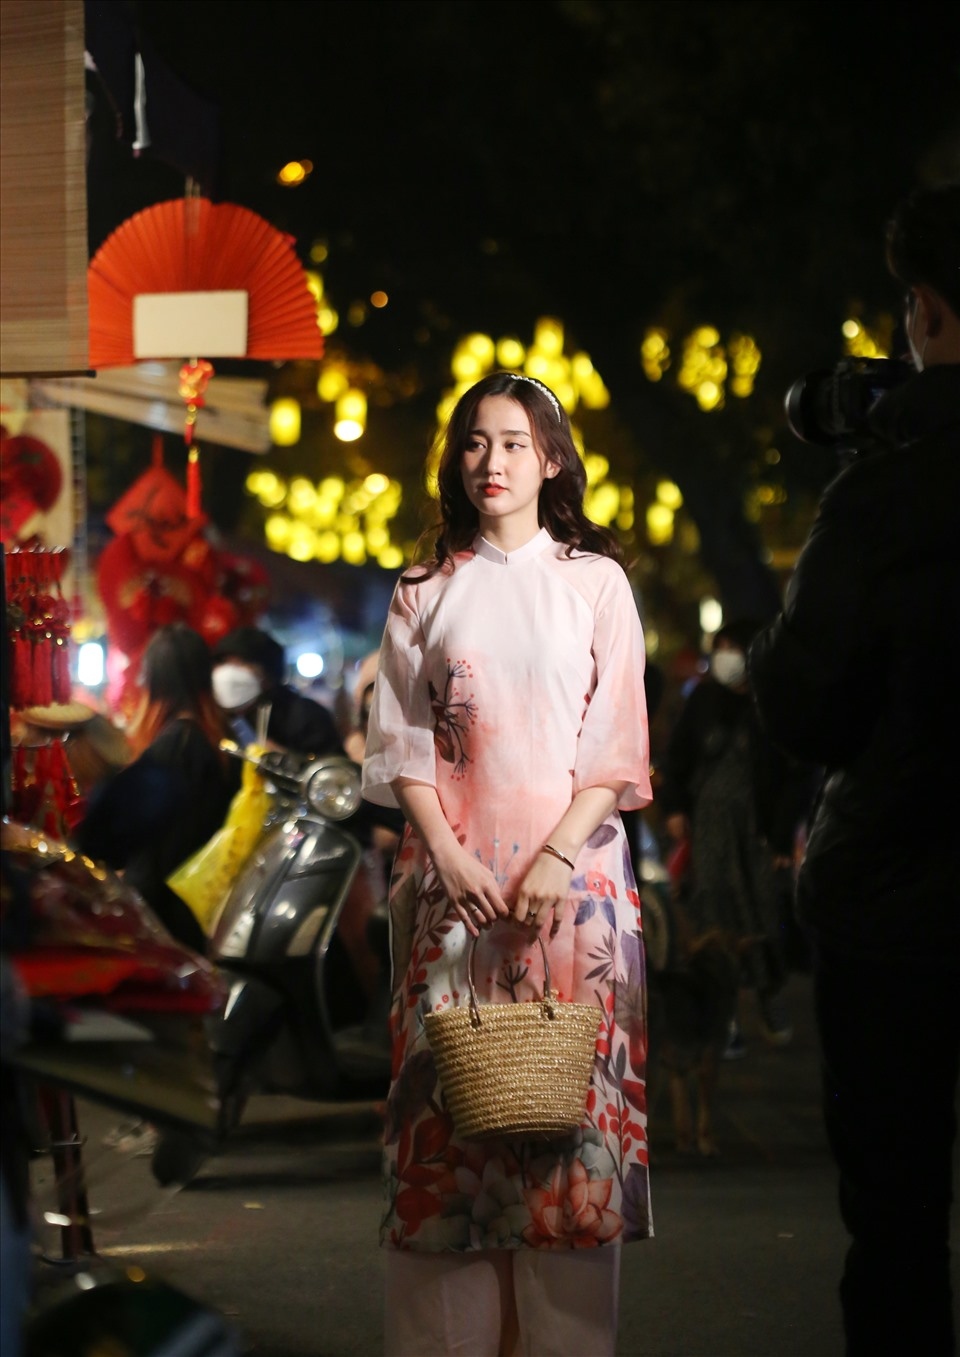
top-left (133, 292), bottom-right (248, 358)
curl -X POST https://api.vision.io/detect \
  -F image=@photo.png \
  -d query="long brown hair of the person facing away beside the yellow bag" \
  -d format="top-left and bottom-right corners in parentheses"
top-left (129, 622), bottom-right (229, 763)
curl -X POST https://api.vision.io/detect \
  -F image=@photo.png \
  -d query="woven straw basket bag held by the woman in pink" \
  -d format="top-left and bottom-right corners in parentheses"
top-left (424, 938), bottom-right (602, 1140)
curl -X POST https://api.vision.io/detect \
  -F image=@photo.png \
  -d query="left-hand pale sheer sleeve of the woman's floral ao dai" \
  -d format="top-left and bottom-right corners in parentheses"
top-left (363, 581), bottom-right (436, 806)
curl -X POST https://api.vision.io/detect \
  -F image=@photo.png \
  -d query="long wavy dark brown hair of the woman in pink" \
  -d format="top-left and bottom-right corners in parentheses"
top-left (403, 372), bottom-right (625, 579)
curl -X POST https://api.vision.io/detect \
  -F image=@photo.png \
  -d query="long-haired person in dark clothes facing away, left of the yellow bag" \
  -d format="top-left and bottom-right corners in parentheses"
top-left (73, 623), bottom-right (240, 953)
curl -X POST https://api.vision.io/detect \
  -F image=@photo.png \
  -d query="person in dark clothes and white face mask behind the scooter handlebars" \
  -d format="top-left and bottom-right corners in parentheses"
top-left (213, 627), bottom-right (344, 756)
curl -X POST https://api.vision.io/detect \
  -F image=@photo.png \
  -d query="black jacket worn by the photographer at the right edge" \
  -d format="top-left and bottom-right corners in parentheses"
top-left (750, 365), bottom-right (960, 966)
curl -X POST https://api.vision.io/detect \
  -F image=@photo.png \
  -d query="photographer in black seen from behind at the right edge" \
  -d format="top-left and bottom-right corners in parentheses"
top-left (750, 185), bottom-right (960, 1357)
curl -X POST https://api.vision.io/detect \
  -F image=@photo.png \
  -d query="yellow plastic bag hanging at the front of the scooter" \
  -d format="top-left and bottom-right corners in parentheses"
top-left (167, 745), bottom-right (270, 934)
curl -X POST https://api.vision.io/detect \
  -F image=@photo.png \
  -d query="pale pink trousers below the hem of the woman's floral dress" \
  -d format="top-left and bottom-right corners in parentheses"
top-left (384, 1246), bottom-right (621, 1357)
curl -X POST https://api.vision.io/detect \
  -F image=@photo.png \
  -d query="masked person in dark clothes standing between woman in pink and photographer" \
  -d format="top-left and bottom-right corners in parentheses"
top-left (659, 619), bottom-right (811, 1058)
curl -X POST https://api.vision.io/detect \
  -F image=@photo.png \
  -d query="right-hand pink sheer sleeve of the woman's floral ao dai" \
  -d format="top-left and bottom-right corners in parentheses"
top-left (573, 567), bottom-right (653, 810)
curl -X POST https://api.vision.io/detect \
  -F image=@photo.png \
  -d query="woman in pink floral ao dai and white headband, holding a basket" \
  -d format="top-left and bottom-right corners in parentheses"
top-left (364, 373), bottom-right (652, 1357)
